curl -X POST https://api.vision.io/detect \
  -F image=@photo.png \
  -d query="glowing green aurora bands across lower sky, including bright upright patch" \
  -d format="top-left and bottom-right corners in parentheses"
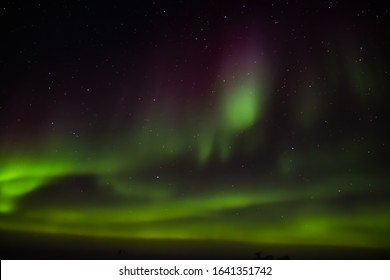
top-left (0, 60), bottom-right (390, 248)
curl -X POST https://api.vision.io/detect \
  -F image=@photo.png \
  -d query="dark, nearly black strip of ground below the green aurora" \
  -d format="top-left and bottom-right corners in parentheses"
top-left (0, 231), bottom-right (390, 260)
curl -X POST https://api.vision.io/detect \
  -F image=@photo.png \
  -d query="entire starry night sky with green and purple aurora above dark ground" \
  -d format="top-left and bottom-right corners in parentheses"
top-left (0, 1), bottom-right (390, 258)
